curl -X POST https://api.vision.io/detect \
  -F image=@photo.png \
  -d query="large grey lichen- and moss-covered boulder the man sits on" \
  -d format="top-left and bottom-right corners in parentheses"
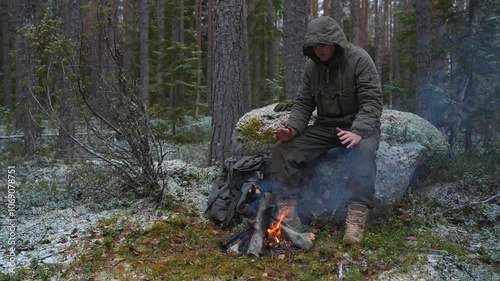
top-left (233, 104), bottom-right (449, 218)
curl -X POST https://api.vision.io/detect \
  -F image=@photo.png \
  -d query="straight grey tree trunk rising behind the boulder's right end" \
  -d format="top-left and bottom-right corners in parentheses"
top-left (415, 0), bottom-right (433, 123)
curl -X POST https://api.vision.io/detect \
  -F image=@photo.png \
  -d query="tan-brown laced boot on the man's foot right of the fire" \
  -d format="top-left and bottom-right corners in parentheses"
top-left (343, 203), bottom-right (368, 244)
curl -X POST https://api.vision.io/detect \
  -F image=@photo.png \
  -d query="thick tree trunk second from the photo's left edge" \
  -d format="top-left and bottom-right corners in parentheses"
top-left (16, 0), bottom-right (42, 156)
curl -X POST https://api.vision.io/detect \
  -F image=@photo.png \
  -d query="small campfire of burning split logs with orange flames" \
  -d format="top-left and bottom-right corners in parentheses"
top-left (221, 192), bottom-right (314, 256)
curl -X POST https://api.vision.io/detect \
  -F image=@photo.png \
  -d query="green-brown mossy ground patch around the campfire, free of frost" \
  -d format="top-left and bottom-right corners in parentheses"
top-left (57, 203), bottom-right (484, 280)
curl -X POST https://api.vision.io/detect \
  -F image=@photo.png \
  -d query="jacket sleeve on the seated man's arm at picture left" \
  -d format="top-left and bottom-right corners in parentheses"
top-left (286, 60), bottom-right (316, 135)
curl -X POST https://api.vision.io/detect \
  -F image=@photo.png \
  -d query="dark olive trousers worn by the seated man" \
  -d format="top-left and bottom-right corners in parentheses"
top-left (271, 126), bottom-right (378, 208)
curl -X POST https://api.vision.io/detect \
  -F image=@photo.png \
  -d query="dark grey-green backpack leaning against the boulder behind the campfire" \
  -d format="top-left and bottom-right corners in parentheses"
top-left (205, 155), bottom-right (269, 226)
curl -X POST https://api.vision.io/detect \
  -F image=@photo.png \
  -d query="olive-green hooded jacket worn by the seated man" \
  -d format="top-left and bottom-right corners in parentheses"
top-left (287, 16), bottom-right (383, 139)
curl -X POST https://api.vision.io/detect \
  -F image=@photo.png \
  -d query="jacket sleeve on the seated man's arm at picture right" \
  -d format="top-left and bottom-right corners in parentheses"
top-left (351, 51), bottom-right (383, 138)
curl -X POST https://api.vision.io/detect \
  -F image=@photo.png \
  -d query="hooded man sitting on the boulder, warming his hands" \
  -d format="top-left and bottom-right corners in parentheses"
top-left (271, 16), bottom-right (383, 243)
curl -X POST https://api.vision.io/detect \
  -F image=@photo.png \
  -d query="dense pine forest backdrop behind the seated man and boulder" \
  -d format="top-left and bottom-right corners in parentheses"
top-left (0, 0), bottom-right (500, 162)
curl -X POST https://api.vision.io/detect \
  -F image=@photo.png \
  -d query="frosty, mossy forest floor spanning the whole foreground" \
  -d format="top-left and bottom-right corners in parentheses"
top-left (0, 138), bottom-right (500, 280)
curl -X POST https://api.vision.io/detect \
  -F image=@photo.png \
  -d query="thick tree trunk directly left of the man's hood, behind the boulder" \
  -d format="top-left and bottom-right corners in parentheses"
top-left (283, 1), bottom-right (307, 99)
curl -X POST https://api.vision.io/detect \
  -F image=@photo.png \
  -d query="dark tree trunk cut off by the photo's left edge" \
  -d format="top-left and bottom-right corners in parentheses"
top-left (0, 0), bottom-right (13, 109)
